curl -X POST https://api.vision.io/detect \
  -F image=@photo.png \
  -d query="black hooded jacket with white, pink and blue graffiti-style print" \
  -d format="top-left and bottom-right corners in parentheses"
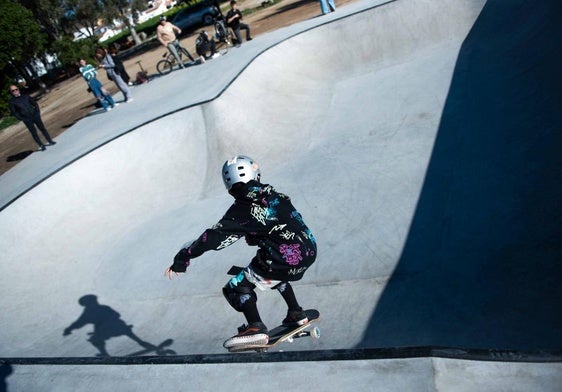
top-left (172, 181), bottom-right (316, 281)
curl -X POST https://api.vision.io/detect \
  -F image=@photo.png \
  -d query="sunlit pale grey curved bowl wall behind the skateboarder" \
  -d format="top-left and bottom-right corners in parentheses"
top-left (10, 0), bottom-right (556, 356)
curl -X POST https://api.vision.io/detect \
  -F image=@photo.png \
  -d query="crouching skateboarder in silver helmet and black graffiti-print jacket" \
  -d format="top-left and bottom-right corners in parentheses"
top-left (165, 155), bottom-right (316, 348)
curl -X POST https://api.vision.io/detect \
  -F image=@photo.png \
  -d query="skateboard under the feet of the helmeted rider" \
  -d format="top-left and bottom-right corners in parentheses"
top-left (227, 309), bottom-right (320, 353)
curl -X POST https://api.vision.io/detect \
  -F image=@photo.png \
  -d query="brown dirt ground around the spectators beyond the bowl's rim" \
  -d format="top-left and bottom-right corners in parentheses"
top-left (0, 0), bottom-right (354, 175)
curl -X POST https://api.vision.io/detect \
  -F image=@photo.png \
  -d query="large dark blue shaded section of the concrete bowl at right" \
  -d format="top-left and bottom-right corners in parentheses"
top-left (361, 1), bottom-right (562, 349)
